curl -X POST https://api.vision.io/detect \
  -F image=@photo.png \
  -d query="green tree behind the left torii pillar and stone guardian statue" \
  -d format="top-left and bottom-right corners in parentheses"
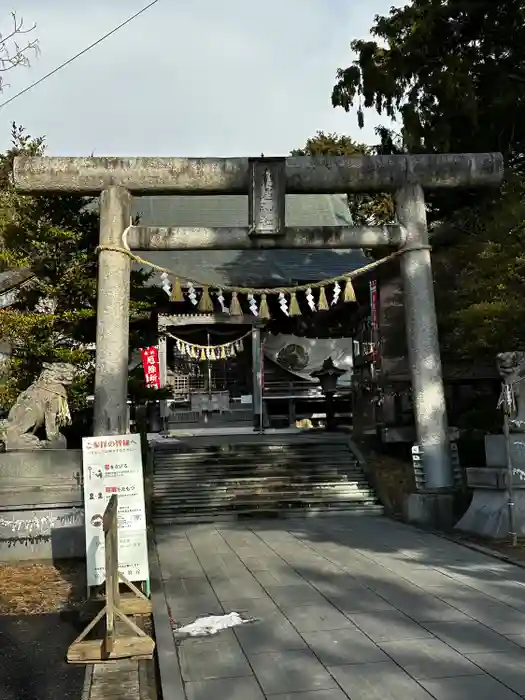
top-left (0, 125), bottom-right (165, 434)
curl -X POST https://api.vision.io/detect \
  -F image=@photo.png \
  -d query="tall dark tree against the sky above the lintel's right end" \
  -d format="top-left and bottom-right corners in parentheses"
top-left (332, 0), bottom-right (525, 165)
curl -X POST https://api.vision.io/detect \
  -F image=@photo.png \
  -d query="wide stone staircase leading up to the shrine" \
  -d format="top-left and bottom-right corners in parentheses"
top-left (152, 433), bottom-right (382, 525)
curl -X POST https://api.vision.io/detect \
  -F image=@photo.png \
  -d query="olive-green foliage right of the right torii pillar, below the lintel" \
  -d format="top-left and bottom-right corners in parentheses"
top-left (434, 175), bottom-right (525, 362)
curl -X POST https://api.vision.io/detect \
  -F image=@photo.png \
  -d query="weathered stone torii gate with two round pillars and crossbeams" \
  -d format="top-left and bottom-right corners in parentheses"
top-left (14, 153), bottom-right (503, 491)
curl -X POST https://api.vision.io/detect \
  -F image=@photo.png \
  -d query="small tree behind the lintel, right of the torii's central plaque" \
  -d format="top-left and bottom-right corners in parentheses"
top-left (291, 131), bottom-right (394, 226)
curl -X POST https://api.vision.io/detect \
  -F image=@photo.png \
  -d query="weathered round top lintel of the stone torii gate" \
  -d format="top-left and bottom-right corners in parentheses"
top-left (13, 153), bottom-right (504, 195)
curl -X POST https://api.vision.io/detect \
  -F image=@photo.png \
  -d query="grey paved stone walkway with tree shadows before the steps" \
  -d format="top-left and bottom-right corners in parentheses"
top-left (157, 516), bottom-right (525, 700)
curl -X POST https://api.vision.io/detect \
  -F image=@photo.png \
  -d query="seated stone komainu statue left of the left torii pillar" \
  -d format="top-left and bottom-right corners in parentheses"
top-left (0, 362), bottom-right (76, 450)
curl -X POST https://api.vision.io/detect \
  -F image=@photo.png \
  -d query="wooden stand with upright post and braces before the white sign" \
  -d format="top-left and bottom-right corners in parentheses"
top-left (67, 494), bottom-right (155, 664)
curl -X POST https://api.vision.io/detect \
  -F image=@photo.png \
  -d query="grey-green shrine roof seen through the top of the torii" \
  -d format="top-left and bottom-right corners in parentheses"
top-left (133, 195), bottom-right (369, 287)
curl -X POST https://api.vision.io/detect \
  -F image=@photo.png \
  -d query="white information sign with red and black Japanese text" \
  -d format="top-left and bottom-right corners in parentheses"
top-left (82, 434), bottom-right (149, 586)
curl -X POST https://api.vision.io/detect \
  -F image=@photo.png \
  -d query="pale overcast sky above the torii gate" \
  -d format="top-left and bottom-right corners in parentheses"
top-left (0, 0), bottom-right (393, 156)
